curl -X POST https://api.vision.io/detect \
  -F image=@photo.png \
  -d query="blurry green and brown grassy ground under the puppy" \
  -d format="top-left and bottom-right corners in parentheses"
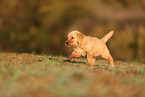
top-left (0, 53), bottom-right (145, 97)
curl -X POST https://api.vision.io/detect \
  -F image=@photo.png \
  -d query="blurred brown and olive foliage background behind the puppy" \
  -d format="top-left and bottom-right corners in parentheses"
top-left (0, 0), bottom-right (145, 62)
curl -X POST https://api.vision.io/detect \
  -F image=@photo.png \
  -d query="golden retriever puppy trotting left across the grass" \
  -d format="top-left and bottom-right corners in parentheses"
top-left (65, 31), bottom-right (114, 68)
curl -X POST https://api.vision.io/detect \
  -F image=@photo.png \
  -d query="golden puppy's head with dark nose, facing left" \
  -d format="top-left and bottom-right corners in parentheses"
top-left (65, 31), bottom-right (85, 47)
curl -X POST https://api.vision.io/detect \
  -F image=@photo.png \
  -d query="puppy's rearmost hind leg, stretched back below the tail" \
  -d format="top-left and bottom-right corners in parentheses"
top-left (101, 47), bottom-right (114, 67)
